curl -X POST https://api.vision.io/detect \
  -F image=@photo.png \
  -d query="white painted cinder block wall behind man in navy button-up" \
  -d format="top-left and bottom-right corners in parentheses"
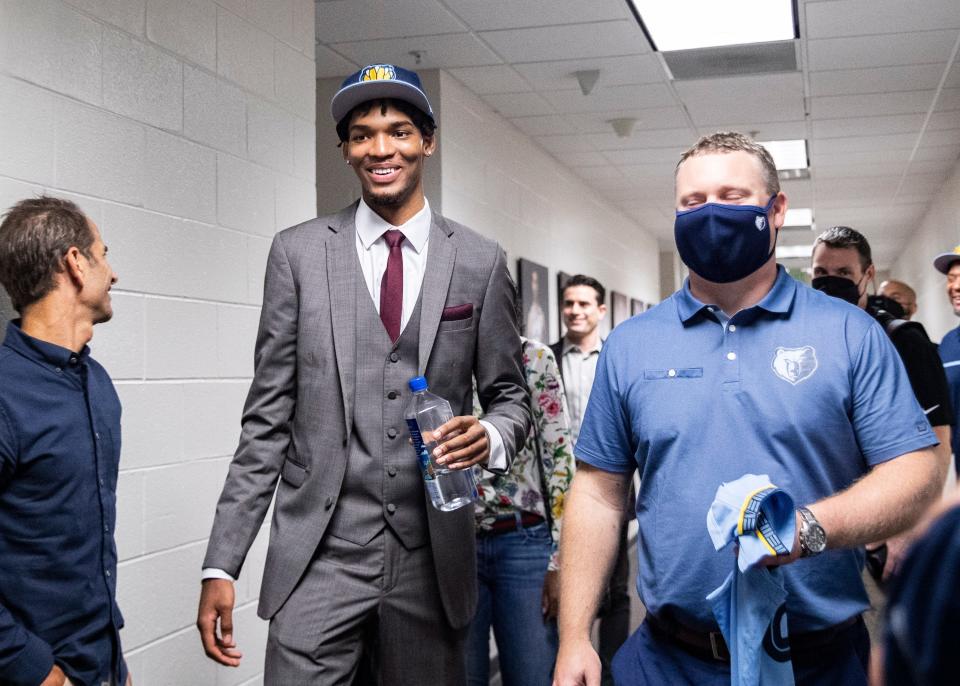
top-left (0, 0), bottom-right (316, 686)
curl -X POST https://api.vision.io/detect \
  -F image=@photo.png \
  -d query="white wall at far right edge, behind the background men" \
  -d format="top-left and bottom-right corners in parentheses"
top-left (890, 162), bottom-right (960, 341)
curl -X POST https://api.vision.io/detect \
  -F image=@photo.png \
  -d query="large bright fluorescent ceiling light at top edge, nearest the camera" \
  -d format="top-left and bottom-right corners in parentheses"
top-left (630, 0), bottom-right (797, 52)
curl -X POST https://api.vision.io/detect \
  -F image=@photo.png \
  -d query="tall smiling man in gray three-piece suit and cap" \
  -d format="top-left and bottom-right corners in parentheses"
top-left (197, 65), bottom-right (530, 686)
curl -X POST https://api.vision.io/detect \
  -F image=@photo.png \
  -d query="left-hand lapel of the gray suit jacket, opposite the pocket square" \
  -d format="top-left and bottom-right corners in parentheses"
top-left (327, 203), bottom-right (359, 437)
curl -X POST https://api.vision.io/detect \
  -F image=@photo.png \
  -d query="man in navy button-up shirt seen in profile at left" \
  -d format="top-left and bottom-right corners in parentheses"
top-left (0, 197), bottom-right (127, 686)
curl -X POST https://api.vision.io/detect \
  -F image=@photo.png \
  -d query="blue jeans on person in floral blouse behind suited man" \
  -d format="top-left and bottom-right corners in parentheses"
top-left (467, 523), bottom-right (557, 686)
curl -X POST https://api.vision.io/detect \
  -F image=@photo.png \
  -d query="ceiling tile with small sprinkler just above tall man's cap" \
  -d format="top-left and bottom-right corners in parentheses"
top-left (330, 33), bottom-right (502, 69)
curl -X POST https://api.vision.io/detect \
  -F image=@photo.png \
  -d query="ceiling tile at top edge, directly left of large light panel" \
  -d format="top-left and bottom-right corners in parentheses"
top-left (445, 0), bottom-right (632, 31)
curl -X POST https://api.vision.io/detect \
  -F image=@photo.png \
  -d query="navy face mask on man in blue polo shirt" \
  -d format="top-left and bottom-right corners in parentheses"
top-left (673, 195), bottom-right (777, 283)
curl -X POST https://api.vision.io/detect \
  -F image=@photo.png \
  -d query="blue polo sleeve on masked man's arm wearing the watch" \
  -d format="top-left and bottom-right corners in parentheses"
top-left (851, 323), bottom-right (937, 466)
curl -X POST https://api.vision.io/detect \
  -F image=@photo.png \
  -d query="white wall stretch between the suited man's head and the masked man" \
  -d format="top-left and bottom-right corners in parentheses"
top-left (440, 71), bottom-right (656, 342)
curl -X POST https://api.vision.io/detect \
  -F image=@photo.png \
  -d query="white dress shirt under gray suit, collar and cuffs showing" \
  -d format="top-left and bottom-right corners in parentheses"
top-left (201, 198), bottom-right (507, 581)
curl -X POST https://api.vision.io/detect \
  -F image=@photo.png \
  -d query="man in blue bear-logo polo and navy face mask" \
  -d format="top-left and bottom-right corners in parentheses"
top-left (555, 133), bottom-right (941, 686)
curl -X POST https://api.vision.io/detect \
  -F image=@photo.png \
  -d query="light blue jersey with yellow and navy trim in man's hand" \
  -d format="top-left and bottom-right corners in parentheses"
top-left (707, 474), bottom-right (796, 686)
